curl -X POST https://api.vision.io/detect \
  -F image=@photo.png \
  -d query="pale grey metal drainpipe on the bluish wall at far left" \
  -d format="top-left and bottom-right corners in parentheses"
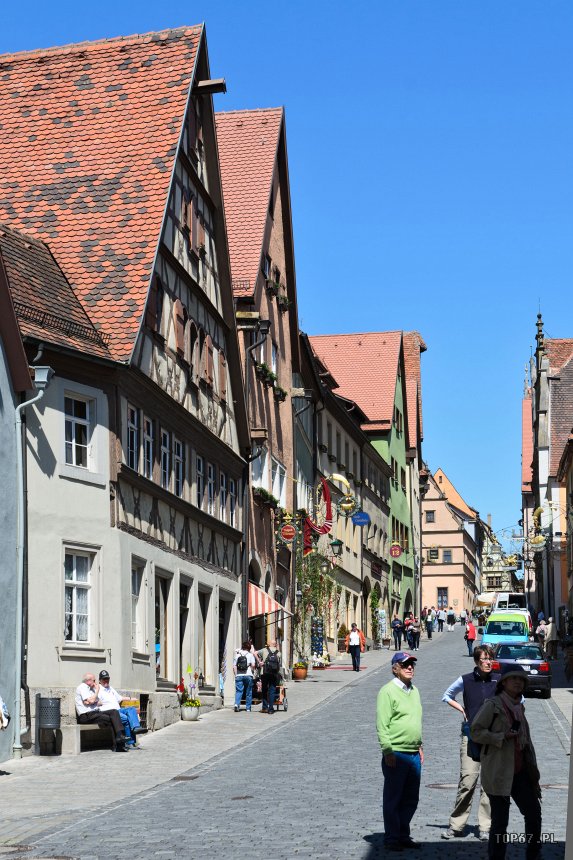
top-left (12, 388), bottom-right (45, 758)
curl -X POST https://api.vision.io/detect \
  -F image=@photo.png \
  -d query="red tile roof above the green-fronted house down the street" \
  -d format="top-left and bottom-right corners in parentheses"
top-left (310, 331), bottom-right (402, 430)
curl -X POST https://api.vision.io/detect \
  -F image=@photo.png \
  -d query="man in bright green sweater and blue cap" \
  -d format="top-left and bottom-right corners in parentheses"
top-left (376, 651), bottom-right (424, 851)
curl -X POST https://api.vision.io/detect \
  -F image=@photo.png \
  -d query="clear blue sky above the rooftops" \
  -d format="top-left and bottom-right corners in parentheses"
top-left (4, 0), bottom-right (573, 544)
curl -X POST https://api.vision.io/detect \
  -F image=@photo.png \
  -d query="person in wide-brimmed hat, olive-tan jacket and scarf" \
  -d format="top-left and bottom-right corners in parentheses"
top-left (470, 664), bottom-right (541, 860)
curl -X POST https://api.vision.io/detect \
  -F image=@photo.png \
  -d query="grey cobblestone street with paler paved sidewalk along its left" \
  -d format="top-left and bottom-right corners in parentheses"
top-left (0, 627), bottom-right (571, 860)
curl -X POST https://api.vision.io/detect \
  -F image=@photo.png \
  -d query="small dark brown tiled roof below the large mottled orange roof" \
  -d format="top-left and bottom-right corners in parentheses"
top-left (0, 224), bottom-right (111, 359)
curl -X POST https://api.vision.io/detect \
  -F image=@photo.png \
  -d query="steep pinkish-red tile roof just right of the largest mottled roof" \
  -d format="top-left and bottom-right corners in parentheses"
top-left (215, 108), bottom-right (284, 297)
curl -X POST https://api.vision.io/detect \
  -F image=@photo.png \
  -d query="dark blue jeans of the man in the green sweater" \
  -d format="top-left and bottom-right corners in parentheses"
top-left (382, 752), bottom-right (422, 845)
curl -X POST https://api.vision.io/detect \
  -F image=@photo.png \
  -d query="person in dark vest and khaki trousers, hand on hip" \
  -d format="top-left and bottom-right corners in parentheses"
top-left (442, 645), bottom-right (499, 842)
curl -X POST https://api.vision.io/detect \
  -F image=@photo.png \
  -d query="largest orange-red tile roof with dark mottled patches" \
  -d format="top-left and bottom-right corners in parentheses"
top-left (0, 26), bottom-right (203, 361)
